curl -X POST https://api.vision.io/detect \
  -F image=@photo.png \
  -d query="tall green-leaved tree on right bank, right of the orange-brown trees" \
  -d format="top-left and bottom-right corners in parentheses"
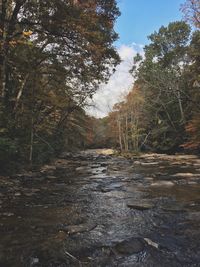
top-left (130, 22), bottom-right (190, 150)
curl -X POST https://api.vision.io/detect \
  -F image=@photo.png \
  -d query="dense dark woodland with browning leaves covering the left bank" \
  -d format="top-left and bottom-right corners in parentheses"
top-left (0, 0), bottom-right (120, 173)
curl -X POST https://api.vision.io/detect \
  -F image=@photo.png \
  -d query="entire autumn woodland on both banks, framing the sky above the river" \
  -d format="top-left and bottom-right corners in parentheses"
top-left (0, 0), bottom-right (200, 175)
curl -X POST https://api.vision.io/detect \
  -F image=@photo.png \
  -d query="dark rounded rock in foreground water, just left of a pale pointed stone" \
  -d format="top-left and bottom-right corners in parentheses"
top-left (114, 237), bottom-right (145, 255)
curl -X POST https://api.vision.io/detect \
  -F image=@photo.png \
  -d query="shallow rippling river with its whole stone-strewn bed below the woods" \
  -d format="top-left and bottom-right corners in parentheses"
top-left (0, 150), bottom-right (200, 267)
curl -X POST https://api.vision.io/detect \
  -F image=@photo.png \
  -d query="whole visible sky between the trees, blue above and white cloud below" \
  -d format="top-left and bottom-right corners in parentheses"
top-left (87, 0), bottom-right (185, 117)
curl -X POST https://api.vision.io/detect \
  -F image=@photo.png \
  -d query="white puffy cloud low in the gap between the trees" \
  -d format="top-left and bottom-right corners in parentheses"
top-left (87, 43), bottom-right (143, 117)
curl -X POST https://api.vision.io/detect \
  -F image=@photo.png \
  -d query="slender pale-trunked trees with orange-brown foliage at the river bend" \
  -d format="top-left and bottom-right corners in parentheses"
top-left (108, 85), bottom-right (147, 152)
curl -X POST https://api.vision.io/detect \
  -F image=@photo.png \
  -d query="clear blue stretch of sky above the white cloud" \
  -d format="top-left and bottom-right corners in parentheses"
top-left (115, 0), bottom-right (184, 46)
